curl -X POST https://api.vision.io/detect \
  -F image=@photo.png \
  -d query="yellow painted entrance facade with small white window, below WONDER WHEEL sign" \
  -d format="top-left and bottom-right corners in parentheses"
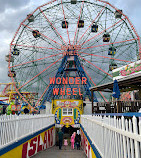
top-left (52, 99), bottom-right (83, 127)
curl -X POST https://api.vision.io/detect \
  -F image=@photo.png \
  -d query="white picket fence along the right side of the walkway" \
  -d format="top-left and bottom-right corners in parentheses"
top-left (81, 115), bottom-right (141, 158)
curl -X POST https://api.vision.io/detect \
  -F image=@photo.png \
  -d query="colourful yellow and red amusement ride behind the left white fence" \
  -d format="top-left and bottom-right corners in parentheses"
top-left (0, 83), bottom-right (37, 114)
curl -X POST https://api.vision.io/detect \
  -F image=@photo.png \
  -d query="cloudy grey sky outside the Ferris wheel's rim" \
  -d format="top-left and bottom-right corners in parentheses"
top-left (0, 0), bottom-right (141, 83)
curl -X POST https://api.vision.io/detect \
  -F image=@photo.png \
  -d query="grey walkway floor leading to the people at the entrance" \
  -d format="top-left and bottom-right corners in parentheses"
top-left (33, 146), bottom-right (86, 158)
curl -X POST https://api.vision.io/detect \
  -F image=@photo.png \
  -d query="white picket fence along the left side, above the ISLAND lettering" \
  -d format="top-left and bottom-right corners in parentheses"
top-left (0, 115), bottom-right (54, 148)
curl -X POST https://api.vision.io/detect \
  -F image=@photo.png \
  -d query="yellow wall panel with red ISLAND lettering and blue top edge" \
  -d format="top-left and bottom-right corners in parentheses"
top-left (0, 125), bottom-right (55, 158)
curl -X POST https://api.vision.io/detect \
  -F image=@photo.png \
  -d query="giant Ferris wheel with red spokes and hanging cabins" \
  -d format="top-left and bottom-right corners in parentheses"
top-left (8, 0), bottom-right (141, 108)
